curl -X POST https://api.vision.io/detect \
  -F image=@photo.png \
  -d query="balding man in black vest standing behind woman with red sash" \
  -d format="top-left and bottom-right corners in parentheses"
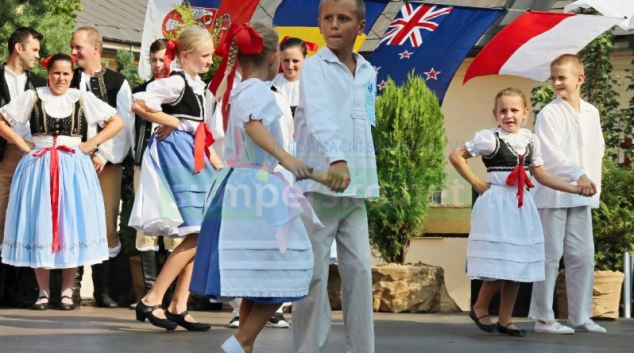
top-left (70, 27), bottom-right (134, 308)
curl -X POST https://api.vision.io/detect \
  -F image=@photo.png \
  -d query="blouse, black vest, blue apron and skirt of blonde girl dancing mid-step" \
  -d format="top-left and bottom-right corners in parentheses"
top-left (129, 63), bottom-right (214, 237)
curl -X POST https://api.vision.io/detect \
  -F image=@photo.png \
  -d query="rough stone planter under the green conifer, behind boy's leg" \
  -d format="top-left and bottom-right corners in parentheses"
top-left (328, 263), bottom-right (462, 313)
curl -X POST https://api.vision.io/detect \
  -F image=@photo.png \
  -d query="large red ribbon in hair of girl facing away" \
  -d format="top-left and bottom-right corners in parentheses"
top-left (209, 23), bottom-right (264, 131)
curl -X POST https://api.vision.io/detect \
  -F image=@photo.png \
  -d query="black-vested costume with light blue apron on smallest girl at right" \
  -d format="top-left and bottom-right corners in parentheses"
top-left (465, 128), bottom-right (544, 282)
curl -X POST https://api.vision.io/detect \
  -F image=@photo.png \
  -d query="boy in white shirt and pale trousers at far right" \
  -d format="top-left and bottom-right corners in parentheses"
top-left (529, 54), bottom-right (606, 334)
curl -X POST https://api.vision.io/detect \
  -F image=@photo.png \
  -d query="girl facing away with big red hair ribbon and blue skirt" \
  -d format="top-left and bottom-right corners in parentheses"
top-left (186, 23), bottom-right (319, 353)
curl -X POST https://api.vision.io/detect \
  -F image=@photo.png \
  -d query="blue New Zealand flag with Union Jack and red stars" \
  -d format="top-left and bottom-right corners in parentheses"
top-left (369, 2), bottom-right (504, 104)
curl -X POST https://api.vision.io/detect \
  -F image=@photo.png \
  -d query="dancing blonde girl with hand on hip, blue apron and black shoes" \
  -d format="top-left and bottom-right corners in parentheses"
top-left (130, 27), bottom-right (221, 331)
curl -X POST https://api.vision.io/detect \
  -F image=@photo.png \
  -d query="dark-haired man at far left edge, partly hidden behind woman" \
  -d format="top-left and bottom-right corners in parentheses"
top-left (0, 27), bottom-right (46, 304)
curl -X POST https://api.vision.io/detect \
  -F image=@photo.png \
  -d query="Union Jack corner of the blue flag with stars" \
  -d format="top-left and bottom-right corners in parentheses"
top-left (381, 2), bottom-right (453, 48)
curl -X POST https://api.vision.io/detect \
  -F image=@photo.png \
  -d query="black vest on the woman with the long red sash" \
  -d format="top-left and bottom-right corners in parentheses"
top-left (29, 91), bottom-right (88, 138)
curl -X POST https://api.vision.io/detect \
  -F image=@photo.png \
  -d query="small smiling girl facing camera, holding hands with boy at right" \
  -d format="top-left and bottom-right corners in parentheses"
top-left (449, 88), bottom-right (591, 337)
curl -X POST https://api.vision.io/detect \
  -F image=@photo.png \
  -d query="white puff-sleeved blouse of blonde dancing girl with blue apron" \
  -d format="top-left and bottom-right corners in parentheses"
top-left (132, 62), bottom-right (210, 134)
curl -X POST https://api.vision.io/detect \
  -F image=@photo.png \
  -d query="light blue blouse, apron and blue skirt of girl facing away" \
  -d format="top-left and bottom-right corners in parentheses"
top-left (190, 79), bottom-right (319, 304)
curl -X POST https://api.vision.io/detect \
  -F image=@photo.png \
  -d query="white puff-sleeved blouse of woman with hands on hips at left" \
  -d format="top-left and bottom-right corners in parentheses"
top-left (0, 87), bottom-right (117, 153)
